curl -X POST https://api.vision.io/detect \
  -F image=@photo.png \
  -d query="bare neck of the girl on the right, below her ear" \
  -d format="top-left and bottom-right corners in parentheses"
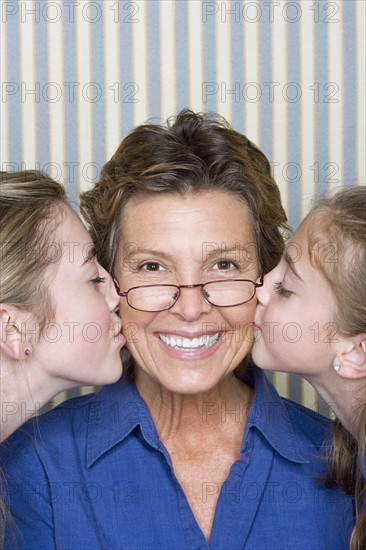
top-left (306, 372), bottom-right (365, 439)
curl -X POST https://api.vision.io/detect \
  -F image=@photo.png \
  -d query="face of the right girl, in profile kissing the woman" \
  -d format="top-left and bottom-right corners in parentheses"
top-left (252, 222), bottom-right (338, 376)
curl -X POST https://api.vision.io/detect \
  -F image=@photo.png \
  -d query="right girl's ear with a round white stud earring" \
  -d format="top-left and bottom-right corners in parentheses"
top-left (334, 334), bottom-right (366, 379)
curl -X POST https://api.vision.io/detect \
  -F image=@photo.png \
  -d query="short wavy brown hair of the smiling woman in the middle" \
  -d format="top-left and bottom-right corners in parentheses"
top-left (81, 109), bottom-right (288, 273)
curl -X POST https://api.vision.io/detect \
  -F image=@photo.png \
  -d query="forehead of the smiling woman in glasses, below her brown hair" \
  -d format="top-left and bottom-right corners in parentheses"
top-left (119, 192), bottom-right (256, 270)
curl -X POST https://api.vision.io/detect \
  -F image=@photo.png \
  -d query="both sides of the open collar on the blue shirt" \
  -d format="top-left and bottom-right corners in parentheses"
top-left (86, 365), bottom-right (318, 467)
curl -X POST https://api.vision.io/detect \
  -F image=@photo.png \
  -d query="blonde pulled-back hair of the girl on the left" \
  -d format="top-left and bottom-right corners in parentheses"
top-left (0, 170), bottom-right (68, 331)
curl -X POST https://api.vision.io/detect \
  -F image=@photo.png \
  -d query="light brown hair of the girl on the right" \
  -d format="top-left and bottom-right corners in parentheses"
top-left (305, 187), bottom-right (366, 550)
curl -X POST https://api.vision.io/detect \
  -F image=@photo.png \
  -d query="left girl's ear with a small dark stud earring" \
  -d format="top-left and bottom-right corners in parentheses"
top-left (0, 304), bottom-right (32, 361)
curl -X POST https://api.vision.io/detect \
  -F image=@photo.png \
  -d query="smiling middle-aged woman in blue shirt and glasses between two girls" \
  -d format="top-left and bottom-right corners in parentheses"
top-left (1, 111), bottom-right (352, 549)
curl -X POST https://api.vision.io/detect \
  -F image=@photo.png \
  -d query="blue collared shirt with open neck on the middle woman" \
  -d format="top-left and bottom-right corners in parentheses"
top-left (2, 368), bottom-right (353, 550)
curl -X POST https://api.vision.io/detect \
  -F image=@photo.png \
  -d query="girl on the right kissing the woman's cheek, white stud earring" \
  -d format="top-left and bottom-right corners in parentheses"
top-left (253, 187), bottom-right (366, 550)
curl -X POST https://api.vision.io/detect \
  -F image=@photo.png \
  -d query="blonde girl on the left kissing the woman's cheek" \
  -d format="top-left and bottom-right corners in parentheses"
top-left (0, 171), bottom-right (125, 441)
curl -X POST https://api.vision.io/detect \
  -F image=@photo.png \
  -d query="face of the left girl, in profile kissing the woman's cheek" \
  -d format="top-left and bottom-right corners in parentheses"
top-left (32, 208), bottom-right (125, 389)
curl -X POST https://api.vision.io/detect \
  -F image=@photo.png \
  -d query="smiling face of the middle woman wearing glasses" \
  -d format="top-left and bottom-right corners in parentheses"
top-left (116, 191), bottom-right (258, 394)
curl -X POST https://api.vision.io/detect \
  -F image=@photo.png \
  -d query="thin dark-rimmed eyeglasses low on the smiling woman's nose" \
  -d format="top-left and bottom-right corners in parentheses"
top-left (113, 275), bottom-right (263, 313)
